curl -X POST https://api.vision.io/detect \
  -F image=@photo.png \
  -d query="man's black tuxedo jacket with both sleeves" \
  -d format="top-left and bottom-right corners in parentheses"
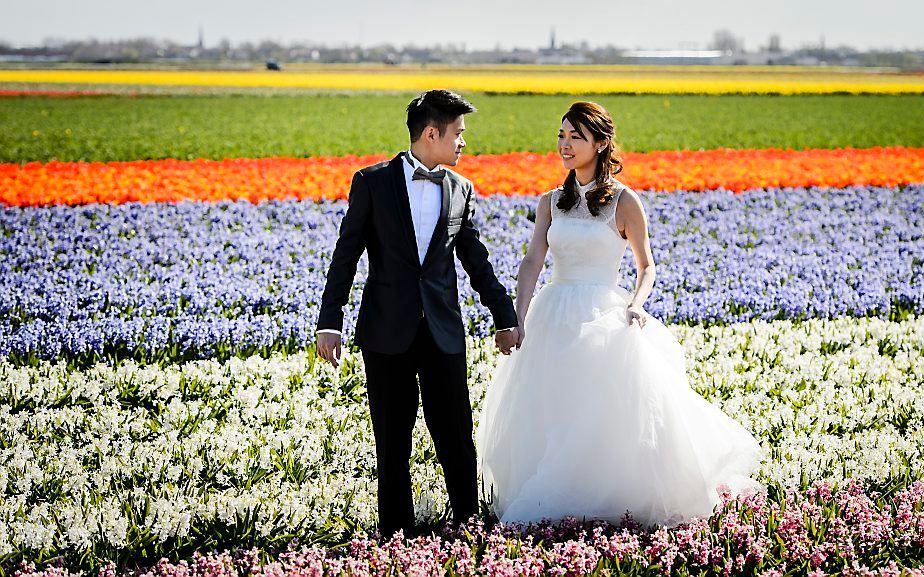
top-left (317, 153), bottom-right (517, 354)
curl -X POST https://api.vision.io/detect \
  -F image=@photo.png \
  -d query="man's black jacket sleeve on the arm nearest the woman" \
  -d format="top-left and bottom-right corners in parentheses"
top-left (456, 183), bottom-right (518, 329)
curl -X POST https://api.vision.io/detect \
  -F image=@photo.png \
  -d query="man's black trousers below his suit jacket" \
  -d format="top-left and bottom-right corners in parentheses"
top-left (363, 318), bottom-right (478, 538)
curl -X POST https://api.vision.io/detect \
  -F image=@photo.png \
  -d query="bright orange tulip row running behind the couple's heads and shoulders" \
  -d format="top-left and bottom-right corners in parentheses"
top-left (0, 147), bottom-right (924, 206)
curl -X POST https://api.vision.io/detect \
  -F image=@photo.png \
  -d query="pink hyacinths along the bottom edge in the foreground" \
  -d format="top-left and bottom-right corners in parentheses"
top-left (13, 480), bottom-right (924, 577)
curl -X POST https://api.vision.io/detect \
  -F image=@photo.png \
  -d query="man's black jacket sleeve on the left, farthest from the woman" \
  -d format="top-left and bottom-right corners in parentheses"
top-left (317, 172), bottom-right (372, 331)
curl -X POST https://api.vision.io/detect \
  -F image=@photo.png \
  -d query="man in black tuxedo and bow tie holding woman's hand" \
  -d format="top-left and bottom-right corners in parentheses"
top-left (317, 90), bottom-right (520, 538)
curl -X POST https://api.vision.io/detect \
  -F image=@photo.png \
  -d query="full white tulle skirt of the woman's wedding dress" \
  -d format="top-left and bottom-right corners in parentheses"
top-left (476, 282), bottom-right (764, 526)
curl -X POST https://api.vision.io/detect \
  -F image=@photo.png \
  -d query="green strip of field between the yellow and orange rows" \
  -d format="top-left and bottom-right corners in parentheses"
top-left (0, 94), bottom-right (924, 163)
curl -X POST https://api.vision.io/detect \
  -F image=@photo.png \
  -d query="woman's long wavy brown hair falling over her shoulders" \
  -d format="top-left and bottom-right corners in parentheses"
top-left (557, 102), bottom-right (622, 216)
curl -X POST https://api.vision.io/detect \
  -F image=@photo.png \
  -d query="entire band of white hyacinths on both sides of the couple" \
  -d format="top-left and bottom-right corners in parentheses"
top-left (0, 317), bottom-right (924, 555)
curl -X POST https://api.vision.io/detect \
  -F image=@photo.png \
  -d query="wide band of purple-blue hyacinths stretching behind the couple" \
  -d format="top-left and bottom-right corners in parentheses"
top-left (0, 185), bottom-right (924, 360)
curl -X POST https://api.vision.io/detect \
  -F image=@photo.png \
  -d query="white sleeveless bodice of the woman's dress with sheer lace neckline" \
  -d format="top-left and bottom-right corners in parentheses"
top-left (546, 181), bottom-right (628, 285)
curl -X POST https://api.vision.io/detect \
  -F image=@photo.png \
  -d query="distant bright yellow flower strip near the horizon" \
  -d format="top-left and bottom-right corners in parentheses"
top-left (0, 66), bottom-right (924, 94)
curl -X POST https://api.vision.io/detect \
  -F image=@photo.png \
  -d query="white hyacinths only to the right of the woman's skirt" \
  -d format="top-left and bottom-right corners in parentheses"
top-left (672, 317), bottom-right (924, 487)
